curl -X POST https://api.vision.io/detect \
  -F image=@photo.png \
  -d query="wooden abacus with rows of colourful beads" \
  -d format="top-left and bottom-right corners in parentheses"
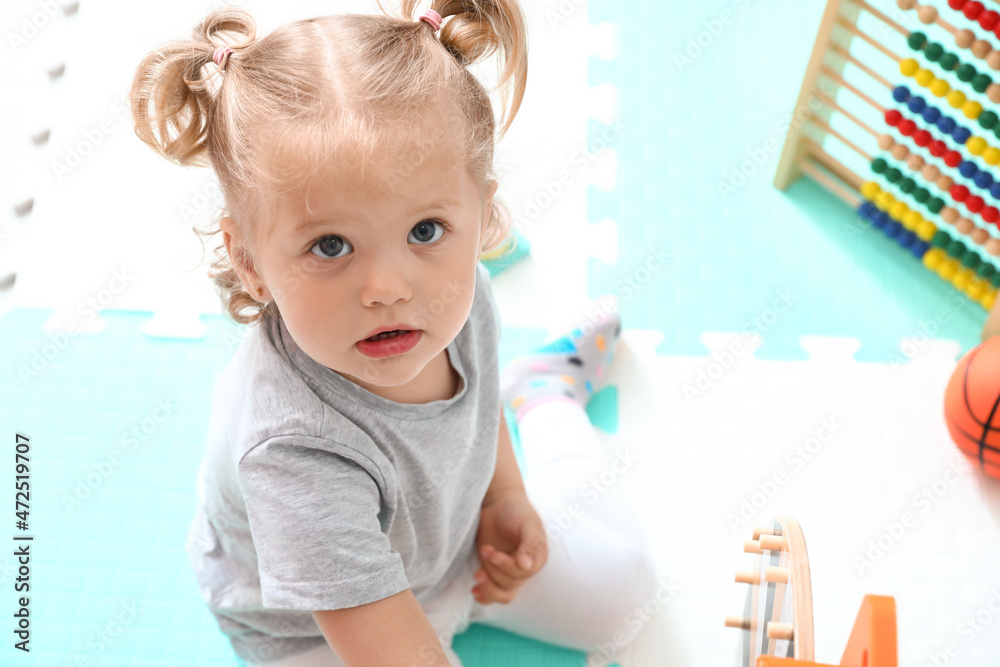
top-left (774, 0), bottom-right (1000, 310)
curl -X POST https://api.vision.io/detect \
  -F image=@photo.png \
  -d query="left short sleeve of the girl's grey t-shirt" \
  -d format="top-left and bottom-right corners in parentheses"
top-left (239, 436), bottom-right (409, 611)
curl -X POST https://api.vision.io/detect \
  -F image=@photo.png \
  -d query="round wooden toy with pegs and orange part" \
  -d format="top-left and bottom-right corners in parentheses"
top-left (726, 516), bottom-right (896, 667)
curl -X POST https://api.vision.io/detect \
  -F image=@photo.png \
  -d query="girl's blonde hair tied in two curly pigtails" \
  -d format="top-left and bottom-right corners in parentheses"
top-left (129, 0), bottom-right (528, 324)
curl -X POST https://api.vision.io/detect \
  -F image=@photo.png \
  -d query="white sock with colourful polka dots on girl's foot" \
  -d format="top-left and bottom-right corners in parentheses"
top-left (500, 296), bottom-right (622, 422)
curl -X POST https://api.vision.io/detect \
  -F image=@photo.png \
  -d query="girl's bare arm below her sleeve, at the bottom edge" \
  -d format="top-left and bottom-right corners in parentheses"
top-left (313, 589), bottom-right (450, 667)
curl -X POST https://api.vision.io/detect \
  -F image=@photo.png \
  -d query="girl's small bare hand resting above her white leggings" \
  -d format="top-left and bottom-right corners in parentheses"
top-left (472, 490), bottom-right (549, 604)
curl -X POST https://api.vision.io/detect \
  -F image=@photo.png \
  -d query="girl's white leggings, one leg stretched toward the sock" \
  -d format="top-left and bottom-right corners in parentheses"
top-left (270, 400), bottom-right (661, 667)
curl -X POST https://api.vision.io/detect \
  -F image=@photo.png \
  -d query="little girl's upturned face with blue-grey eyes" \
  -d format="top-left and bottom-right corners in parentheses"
top-left (235, 145), bottom-right (496, 403)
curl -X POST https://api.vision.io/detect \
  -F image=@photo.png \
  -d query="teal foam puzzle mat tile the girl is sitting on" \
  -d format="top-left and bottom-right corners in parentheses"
top-left (0, 310), bottom-right (611, 667)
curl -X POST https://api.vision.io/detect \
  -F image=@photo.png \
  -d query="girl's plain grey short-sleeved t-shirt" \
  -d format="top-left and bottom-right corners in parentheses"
top-left (187, 264), bottom-right (501, 662)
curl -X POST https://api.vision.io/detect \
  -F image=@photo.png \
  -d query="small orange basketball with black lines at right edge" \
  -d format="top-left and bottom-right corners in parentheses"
top-left (944, 336), bottom-right (1000, 478)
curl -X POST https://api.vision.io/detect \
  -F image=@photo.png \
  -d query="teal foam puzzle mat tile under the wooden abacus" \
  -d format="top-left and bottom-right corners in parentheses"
top-left (588, 0), bottom-right (986, 362)
